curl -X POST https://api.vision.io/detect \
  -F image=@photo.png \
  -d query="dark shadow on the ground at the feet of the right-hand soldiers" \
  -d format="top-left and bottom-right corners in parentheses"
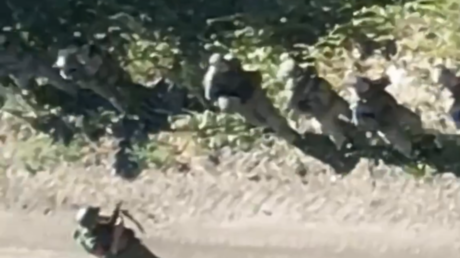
top-left (294, 126), bottom-right (460, 177)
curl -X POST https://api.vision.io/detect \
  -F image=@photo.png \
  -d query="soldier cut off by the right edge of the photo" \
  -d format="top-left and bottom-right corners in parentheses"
top-left (432, 64), bottom-right (460, 129)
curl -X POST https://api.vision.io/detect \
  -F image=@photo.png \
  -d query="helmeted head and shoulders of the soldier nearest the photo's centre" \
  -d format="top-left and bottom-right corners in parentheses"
top-left (203, 53), bottom-right (244, 88)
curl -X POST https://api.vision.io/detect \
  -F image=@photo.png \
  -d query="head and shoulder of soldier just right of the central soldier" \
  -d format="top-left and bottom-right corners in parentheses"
top-left (276, 54), bottom-right (317, 90)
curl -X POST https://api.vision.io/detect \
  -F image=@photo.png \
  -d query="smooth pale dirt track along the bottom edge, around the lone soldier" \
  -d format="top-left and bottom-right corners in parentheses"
top-left (0, 212), bottom-right (459, 258)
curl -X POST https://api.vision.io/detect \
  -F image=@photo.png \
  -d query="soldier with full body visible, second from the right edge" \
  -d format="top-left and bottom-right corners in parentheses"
top-left (345, 74), bottom-right (432, 158)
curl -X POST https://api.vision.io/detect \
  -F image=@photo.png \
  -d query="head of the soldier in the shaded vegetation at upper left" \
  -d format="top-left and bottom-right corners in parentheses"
top-left (53, 44), bottom-right (103, 81)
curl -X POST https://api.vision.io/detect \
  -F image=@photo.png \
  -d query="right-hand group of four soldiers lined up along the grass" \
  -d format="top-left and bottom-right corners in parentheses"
top-left (203, 54), bottom-right (460, 158)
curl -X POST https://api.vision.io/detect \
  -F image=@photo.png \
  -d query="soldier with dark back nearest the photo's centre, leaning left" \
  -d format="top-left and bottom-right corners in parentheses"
top-left (203, 54), bottom-right (301, 143)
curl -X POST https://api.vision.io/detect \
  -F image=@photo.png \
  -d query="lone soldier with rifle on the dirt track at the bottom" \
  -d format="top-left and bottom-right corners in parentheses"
top-left (73, 205), bottom-right (155, 258)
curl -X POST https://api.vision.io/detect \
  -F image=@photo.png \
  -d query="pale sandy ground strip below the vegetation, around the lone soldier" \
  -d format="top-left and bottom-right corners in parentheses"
top-left (0, 156), bottom-right (460, 258)
